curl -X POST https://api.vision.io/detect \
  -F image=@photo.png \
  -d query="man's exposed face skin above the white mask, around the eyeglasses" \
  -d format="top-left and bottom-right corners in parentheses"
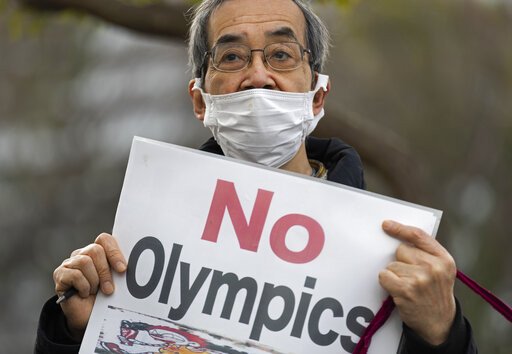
top-left (204, 0), bottom-right (312, 95)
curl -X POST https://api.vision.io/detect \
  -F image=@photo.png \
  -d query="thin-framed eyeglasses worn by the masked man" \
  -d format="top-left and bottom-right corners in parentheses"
top-left (205, 42), bottom-right (311, 72)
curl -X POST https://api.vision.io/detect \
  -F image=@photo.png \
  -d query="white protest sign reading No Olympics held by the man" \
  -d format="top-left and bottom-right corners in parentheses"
top-left (80, 138), bottom-right (441, 354)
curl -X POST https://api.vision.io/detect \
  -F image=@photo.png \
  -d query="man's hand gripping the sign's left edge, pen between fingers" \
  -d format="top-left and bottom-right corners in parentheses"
top-left (53, 233), bottom-right (126, 340)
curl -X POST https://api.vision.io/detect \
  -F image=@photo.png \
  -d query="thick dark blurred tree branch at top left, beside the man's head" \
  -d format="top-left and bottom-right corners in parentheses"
top-left (19, 0), bottom-right (190, 39)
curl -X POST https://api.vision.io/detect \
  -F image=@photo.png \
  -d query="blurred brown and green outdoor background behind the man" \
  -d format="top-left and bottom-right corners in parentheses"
top-left (0, 0), bottom-right (512, 354)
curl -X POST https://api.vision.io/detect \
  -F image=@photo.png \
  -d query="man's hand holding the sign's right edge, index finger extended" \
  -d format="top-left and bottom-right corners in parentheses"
top-left (379, 220), bottom-right (456, 345)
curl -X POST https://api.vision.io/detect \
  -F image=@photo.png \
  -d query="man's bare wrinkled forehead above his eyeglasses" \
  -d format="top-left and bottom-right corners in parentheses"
top-left (208, 0), bottom-right (306, 46)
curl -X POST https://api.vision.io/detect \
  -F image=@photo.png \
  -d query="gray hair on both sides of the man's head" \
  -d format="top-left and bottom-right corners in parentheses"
top-left (188, 0), bottom-right (329, 82)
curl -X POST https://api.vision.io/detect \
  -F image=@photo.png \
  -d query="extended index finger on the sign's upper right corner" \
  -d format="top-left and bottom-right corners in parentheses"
top-left (382, 220), bottom-right (446, 256)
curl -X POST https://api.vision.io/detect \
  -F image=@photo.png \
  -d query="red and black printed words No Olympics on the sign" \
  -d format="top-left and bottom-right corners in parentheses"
top-left (126, 180), bottom-right (374, 352)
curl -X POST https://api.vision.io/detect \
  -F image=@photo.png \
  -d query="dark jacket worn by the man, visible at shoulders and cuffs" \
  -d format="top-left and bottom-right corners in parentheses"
top-left (34, 137), bottom-right (477, 354)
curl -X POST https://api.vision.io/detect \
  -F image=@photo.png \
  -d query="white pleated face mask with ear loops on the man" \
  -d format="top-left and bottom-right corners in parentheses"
top-left (193, 75), bottom-right (329, 167)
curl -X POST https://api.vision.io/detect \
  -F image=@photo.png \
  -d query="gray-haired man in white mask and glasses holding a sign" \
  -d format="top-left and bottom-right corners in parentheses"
top-left (36, 0), bottom-right (476, 353)
